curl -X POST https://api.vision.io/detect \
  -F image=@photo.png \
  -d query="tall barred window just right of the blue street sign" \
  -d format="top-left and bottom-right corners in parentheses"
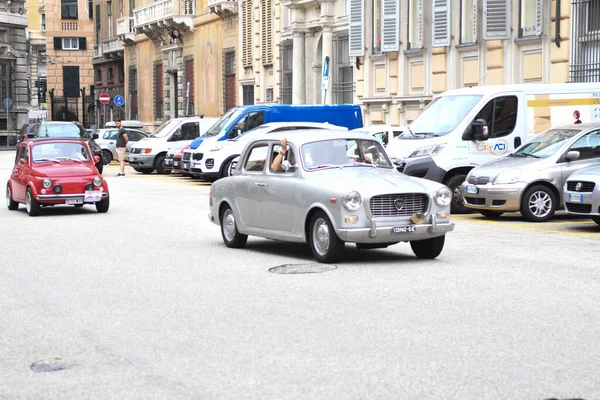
top-left (332, 34), bottom-right (354, 104)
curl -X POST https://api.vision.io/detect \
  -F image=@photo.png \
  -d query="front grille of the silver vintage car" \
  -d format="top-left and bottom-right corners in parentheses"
top-left (369, 193), bottom-right (429, 217)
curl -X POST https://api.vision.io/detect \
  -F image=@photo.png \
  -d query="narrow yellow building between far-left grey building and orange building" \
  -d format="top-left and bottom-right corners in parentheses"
top-left (25, 0), bottom-right (48, 114)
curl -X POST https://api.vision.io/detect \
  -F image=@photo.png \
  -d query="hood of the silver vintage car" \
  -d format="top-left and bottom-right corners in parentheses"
top-left (308, 167), bottom-right (443, 197)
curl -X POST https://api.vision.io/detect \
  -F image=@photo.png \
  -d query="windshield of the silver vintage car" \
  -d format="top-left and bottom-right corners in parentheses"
top-left (300, 139), bottom-right (392, 171)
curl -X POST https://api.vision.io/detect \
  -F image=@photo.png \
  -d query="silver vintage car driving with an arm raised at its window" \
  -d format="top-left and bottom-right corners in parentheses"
top-left (209, 130), bottom-right (454, 262)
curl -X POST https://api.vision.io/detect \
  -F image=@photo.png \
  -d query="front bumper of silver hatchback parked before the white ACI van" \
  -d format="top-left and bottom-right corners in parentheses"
top-left (460, 182), bottom-right (527, 212)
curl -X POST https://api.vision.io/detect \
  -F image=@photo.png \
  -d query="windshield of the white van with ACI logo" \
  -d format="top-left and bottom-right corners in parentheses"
top-left (400, 95), bottom-right (482, 138)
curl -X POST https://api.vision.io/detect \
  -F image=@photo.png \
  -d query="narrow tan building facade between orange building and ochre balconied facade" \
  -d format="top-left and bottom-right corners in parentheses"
top-left (92, 0), bottom-right (128, 127)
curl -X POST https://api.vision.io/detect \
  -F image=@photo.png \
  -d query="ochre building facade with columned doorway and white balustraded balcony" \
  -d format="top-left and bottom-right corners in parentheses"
top-left (117, 0), bottom-right (238, 130)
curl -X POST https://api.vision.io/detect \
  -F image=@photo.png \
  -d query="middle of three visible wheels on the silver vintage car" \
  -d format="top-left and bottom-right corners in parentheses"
top-left (308, 211), bottom-right (345, 263)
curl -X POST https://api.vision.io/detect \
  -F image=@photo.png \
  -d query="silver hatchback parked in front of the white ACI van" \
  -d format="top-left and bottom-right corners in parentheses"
top-left (461, 123), bottom-right (600, 222)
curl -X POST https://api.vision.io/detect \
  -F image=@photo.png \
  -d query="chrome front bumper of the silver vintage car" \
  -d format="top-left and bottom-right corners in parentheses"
top-left (337, 216), bottom-right (454, 243)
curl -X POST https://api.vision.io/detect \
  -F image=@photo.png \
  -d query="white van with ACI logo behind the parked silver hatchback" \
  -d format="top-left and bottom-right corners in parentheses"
top-left (386, 83), bottom-right (600, 213)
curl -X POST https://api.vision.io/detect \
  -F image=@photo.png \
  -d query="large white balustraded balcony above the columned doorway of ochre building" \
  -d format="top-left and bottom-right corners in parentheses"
top-left (133, 0), bottom-right (195, 44)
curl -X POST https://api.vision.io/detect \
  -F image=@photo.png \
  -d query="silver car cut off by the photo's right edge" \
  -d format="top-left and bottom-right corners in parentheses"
top-left (563, 162), bottom-right (600, 225)
